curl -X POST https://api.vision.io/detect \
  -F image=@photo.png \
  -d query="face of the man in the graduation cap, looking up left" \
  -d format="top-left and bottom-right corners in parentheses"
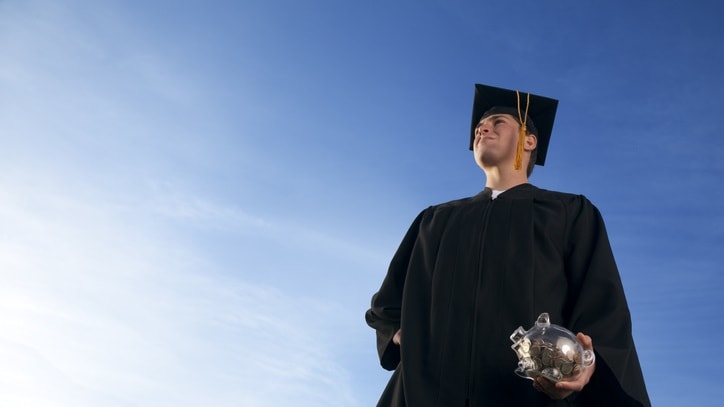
top-left (473, 114), bottom-right (520, 169)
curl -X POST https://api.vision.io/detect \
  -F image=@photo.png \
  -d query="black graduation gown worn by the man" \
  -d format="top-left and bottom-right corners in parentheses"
top-left (365, 184), bottom-right (650, 407)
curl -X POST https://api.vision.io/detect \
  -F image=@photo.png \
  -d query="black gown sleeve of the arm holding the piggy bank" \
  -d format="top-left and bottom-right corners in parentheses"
top-left (566, 196), bottom-right (651, 406)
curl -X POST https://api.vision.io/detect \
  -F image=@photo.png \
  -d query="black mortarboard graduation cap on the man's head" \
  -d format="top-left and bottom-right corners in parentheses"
top-left (470, 84), bottom-right (558, 165)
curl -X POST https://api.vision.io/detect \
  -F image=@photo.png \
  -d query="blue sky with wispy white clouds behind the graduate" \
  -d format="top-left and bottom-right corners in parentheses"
top-left (0, 0), bottom-right (724, 407)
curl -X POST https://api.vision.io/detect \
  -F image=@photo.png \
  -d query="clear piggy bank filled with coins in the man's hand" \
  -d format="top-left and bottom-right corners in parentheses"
top-left (510, 312), bottom-right (596, 382)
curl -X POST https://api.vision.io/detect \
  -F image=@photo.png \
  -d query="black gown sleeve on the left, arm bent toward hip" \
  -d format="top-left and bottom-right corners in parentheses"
top-left (365, 211), bottom-right (425, 370)
